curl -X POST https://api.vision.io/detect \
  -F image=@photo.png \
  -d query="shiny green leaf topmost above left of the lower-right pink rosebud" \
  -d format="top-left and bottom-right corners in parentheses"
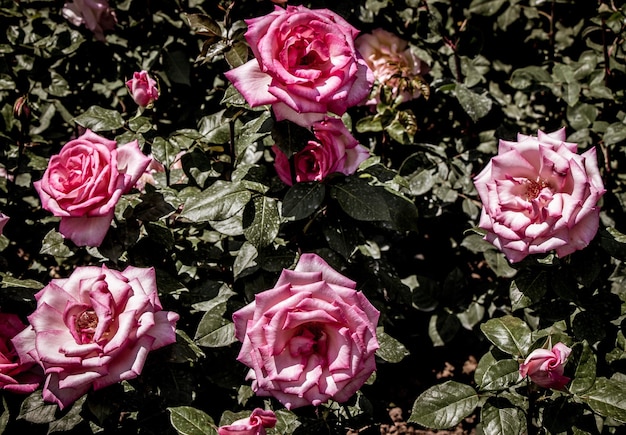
top-left (480, 316), bottom-right (532, 357)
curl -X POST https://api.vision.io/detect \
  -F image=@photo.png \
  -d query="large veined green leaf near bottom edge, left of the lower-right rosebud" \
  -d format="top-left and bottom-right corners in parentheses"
top-left (408, 381), bottom-right (480, 429)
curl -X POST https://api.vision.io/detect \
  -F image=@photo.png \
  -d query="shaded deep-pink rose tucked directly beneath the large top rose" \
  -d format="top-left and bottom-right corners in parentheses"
top-left (273, 118), bottom-right (370, 186)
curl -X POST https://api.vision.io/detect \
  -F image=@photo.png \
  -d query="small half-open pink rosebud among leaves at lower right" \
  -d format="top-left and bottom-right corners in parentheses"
top-left (519, 343), bottom-right (572, 390)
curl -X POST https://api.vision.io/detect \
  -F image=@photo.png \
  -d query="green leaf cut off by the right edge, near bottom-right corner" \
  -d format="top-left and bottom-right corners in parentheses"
top-left (580, 378), bottom-right (626, 423)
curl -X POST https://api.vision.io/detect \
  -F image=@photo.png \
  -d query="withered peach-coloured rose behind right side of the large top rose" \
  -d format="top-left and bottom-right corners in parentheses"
top-left (355, 29), bottom-right (428, 104)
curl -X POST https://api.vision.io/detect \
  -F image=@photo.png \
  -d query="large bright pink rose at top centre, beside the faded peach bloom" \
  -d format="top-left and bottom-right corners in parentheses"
top-left (226, 6), bottom-right (374, 127)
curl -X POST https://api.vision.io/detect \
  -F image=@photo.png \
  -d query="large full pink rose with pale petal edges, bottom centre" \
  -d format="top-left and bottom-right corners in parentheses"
top-left (233, 254), bottom-right (380, 409)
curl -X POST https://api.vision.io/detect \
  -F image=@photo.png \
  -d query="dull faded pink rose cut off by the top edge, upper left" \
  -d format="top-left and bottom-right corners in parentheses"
top-left (61, 0), bottom-right (117, 41)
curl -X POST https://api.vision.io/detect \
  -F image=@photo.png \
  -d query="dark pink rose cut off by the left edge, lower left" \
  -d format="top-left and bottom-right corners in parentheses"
top-left (0, 313), bottom-right (42, 394)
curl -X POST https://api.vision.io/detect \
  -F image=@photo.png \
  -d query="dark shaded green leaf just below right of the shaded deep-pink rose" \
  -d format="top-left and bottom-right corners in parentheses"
top-left (331, 177), bottom-right (391, 221)
